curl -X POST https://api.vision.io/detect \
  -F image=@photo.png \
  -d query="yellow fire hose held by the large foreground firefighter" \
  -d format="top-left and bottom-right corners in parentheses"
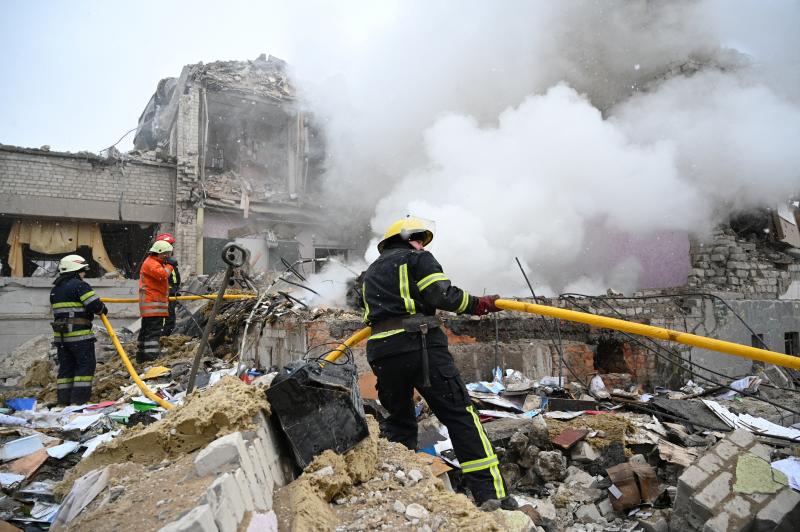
top-left (325, 299), bottom-right (800, 370)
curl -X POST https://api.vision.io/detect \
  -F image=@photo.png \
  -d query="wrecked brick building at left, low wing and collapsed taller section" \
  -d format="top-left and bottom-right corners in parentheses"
top-left (0, 55), bottom-right (356, 353)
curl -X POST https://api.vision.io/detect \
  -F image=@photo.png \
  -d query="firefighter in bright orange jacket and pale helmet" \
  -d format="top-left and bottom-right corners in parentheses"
top-left (136, 240), bottom-right (172, 363)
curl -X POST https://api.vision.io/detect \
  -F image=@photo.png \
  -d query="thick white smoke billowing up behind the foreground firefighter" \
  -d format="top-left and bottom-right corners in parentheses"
top-left (284, 0), bottom-right (800, 295)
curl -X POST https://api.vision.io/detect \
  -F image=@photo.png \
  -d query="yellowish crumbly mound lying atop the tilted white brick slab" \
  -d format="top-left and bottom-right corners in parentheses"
top-left (58, 377), bottom-right (268, 496)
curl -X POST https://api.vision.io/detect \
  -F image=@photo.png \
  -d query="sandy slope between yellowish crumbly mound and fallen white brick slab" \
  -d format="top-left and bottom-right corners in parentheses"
top-left (67, 454), bottom-right (214, 530)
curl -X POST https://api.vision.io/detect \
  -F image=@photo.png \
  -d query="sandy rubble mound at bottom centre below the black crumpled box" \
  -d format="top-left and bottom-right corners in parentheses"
top-left (275, 418), bottom-right (504, 531)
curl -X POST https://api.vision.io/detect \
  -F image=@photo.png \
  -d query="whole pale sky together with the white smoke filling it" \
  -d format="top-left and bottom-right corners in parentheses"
top-left (0, 0), bottom-right (800, 295)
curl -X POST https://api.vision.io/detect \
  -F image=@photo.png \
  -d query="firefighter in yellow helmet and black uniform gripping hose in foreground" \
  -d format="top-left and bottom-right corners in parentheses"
top-left (362, 217), bottom-right (515, 509)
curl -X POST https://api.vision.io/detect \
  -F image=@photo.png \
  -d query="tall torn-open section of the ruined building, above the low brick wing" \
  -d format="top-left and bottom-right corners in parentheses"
top-left (135, 56), bottom-right (355, 273)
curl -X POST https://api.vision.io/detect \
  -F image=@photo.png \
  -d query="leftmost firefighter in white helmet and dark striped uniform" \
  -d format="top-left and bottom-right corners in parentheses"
top-left (50, 255), bottom-right (108, 405)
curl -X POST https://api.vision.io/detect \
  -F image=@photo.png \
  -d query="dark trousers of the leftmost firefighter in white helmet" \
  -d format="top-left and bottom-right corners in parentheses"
top-left (56, 340), bottom-right (96, 405)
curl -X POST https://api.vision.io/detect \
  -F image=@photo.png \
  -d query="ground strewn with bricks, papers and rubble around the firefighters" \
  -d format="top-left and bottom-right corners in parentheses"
top-left (0, 286), bottom-right (800, 532)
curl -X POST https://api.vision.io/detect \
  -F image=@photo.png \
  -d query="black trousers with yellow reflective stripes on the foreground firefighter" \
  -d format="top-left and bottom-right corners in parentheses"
top-left (370, 347), bottom-right (506, 505)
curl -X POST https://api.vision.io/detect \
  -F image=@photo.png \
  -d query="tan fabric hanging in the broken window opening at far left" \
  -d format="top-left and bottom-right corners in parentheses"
top-left (7, 220), bottom-right (117, 277)
